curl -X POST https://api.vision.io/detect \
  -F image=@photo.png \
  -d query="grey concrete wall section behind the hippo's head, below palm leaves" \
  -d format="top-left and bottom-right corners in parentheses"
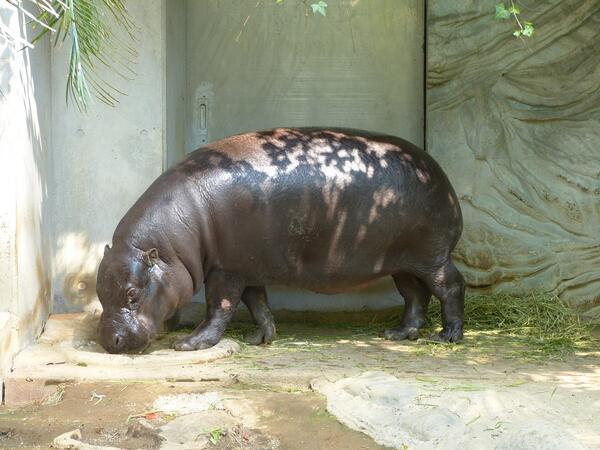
top-left (51, 0), bottom-right (166, 312)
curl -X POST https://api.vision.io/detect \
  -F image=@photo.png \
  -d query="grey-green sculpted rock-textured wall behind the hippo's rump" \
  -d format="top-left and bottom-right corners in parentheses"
top-left (427, 0), bottom-right (600, 321)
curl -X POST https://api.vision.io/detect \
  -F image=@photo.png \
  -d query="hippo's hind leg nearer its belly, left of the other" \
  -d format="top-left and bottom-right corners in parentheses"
top-left (384, 273), bottom-right (431, 341)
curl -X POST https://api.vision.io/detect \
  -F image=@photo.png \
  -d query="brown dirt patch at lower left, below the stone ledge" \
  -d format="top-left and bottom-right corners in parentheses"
top-left (0, 382), bottom-right (383, 450)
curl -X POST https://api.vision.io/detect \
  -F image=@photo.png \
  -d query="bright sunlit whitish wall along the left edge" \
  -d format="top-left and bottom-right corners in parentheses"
top-left (0, 2), bottom-right (52, 379)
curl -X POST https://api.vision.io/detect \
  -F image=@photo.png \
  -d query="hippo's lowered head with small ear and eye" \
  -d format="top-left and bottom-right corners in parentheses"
top-left (96, 245), bottom-right (181, 353)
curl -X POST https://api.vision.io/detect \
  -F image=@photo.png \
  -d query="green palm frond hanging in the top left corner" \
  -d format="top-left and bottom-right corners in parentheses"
top-left (0, 0), bottom-right (137, 111)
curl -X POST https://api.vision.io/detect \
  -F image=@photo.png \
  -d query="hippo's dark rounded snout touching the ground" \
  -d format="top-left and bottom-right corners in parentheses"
top-left (98, 312), bottom-right (152, 354)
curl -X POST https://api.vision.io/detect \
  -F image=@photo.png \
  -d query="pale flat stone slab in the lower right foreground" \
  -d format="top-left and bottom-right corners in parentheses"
top-left (312, 371), bottom-right (600, 450)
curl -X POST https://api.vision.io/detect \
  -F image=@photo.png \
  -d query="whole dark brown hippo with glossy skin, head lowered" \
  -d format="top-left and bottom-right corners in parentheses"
top-left (97, 128), bottom-right (464, 353)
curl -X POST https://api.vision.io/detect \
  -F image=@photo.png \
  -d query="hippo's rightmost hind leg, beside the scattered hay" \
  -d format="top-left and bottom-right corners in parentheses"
top-left (423, 257), bottom-right (465, 342)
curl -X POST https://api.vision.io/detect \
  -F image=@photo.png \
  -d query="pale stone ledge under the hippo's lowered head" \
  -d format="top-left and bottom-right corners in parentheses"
top-left (5, 313), bottom-right (240, 405)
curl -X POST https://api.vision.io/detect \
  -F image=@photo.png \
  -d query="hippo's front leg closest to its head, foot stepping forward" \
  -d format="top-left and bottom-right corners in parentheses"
top-left (172, 271), bottom-right (245, 351)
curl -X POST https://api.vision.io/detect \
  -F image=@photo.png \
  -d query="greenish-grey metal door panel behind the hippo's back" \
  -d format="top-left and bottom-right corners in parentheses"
top-left (186, 0), bottom-right (424, 151)
